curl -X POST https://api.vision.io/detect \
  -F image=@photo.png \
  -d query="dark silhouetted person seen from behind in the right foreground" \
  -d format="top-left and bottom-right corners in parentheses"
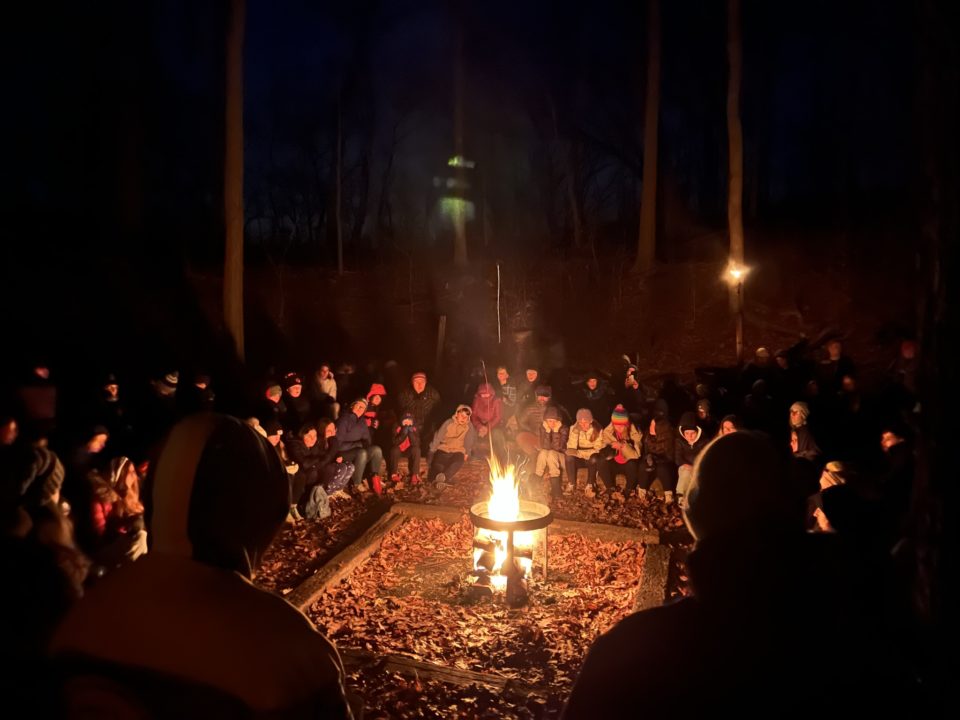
top-left (564, 432), bottom-right (908, 720)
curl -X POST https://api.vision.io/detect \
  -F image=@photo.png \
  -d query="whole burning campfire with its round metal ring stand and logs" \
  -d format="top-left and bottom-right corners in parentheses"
top-left (470, 453), bottom-right (553, 606)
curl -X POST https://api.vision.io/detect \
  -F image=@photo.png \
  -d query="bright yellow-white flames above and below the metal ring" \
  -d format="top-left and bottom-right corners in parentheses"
top-left (473, 453), bottom-right (536, 591)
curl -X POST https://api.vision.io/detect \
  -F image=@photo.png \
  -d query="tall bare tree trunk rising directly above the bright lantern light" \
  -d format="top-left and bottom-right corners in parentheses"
top-left (727, 0), bottom-right (743, 265)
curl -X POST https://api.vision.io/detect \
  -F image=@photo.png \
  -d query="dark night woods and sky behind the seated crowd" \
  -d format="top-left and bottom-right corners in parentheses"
top-left (0, 0), bottom-right (960, 680)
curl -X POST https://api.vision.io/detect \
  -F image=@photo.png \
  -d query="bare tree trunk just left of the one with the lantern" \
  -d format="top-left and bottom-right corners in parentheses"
top-left (633, 0), bottom-right (660, 273)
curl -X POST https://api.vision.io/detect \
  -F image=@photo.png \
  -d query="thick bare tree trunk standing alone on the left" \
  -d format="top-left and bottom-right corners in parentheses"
top-left (223, 0), bottom-right (246, 360)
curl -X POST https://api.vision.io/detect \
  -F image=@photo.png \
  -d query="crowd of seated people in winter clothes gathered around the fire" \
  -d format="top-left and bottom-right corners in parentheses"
top-left (0, 340), bottom-right (919, 716)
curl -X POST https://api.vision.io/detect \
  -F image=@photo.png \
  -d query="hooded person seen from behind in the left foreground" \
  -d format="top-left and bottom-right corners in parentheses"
top-left (52, 413), bottom-right (352, 718)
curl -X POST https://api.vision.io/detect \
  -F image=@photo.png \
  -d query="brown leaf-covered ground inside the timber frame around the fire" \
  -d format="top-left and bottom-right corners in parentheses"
top-left (308, 518), bottom-right (643, 697)
